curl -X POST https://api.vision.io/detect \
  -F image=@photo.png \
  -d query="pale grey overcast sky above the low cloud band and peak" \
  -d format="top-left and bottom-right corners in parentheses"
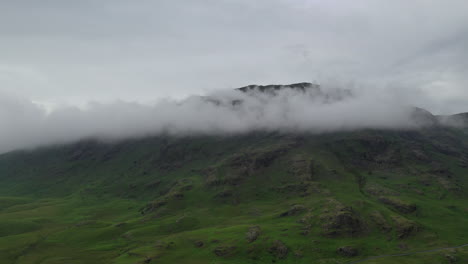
top-left (0, 0), bottom-right (468, 113)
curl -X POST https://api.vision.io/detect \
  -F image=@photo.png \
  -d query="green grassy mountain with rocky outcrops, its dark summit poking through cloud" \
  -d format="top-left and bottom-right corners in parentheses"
top-left (0, 84), bottom-right (468, 264)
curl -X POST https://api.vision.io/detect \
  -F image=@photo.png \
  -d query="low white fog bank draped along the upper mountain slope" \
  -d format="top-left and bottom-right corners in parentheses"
top-left (0, 83), bottom-right (458, 152)
